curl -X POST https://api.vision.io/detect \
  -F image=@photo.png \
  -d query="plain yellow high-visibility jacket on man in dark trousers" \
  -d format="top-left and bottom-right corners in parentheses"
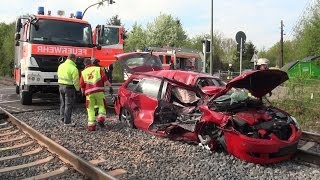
top-left (58, 59), bottom-right (80, 91)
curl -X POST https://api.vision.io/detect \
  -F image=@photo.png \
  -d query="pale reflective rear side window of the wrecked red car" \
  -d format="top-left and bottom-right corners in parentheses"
top-left (135, 79), bottom-right (161, 98)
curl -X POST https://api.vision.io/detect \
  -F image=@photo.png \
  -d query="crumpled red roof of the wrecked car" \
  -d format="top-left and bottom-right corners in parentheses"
top-left (136, 70), bottom-right (219, 86)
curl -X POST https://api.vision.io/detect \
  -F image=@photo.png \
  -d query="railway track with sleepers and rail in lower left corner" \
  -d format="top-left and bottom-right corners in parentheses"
top-left (0, 108), bottom-right (125, 179)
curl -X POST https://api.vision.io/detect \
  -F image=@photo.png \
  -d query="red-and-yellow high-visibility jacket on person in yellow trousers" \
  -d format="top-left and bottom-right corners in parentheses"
top-left (80, 65), bottom-right (108, 96)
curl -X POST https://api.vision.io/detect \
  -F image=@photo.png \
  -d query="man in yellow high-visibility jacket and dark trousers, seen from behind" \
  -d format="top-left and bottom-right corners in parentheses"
top-left (58, 54), bottom-right (80, 126)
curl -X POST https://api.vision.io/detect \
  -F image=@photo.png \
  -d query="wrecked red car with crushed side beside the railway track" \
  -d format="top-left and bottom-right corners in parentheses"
top-left (115, 57), bottom-right (302, 164)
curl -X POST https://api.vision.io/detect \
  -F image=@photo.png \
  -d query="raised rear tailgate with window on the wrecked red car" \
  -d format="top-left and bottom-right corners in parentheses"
top-left (116, 52), bottom-right (163, 74)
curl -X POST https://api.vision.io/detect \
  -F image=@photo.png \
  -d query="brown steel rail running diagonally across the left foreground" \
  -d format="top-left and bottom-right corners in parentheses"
top-left (0, 107), bottom-right (116, 180)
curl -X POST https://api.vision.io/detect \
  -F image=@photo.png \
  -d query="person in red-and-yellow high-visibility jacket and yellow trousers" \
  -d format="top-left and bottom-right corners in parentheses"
top-left (80, 58), bottom-right (113, 131)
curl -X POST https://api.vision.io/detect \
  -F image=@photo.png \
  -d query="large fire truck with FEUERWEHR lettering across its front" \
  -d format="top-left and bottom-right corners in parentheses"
top-left (14, 7), bottom-right (123, 105)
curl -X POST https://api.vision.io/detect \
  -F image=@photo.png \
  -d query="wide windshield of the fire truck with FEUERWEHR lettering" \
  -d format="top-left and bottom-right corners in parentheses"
top-left (30, 19), bottom-right (92, 47)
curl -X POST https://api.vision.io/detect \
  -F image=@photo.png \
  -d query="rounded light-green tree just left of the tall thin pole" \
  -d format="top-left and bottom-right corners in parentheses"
top-left (147, 14), bottom-right (187, 47)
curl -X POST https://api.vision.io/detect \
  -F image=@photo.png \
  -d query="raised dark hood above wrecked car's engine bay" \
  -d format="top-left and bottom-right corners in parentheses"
top-left (214, 69), bottom-right (289, 98)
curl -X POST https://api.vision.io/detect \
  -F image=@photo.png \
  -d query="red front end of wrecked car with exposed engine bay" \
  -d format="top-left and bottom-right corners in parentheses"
top-left (224, 108), bottom-right (302, 164)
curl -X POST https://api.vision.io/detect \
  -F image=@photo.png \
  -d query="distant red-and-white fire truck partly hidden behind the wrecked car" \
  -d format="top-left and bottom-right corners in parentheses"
top-left (148, 47), bottom-right (203, 72)
